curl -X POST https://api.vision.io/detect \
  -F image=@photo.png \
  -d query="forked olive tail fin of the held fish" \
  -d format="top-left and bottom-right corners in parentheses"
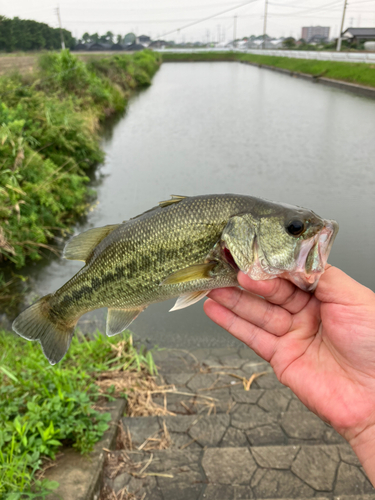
top-left (12, 294), bottom-right (77, 365)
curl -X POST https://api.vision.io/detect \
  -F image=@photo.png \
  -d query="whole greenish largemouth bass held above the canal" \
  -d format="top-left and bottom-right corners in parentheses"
top-left (12, 194), bottom-right (338, 364)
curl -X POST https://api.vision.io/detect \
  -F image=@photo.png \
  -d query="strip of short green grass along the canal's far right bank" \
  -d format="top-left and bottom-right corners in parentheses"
top-left (163, 52), bottom-right (375, 87)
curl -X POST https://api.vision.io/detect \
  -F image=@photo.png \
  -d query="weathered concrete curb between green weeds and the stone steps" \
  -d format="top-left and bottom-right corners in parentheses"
top-left (44, 399), bottom-right (126, 500)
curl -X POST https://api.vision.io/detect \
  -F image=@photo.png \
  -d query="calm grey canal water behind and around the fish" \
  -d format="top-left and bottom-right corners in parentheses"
top-left (22, 63), bottom-right (375, 348)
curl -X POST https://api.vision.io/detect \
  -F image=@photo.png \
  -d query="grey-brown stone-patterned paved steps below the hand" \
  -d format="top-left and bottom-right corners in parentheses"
top-left (102, 348), bottom-right (375, 500)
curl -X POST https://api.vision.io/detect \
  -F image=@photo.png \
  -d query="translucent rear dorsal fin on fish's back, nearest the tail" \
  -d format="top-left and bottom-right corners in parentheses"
top-left (63, 224), bottom-right (120, 262)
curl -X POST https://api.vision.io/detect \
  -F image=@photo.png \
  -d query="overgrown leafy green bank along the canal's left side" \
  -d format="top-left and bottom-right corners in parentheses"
top-left (0, 50), bottom-right (160, 307)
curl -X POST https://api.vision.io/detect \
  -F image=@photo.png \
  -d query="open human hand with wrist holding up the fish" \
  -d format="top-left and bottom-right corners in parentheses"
top-left (204, 266), bottom-right (375, 483)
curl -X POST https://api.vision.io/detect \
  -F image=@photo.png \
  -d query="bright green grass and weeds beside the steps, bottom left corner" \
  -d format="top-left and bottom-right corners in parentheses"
top-left (0, 331), bottom-right (155, 500)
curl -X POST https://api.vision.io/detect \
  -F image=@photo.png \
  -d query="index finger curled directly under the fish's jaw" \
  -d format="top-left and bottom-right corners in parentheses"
top-left (238, 271), bottom-right (312, 314)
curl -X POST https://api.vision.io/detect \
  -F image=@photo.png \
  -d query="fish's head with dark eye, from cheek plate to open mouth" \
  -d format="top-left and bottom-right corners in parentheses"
top-left (247, 205), bottom-right (339, 291)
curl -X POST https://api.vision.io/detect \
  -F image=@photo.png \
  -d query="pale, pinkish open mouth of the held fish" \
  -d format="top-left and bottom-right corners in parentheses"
top-left (288, 220), bottom-right (339, 292)
